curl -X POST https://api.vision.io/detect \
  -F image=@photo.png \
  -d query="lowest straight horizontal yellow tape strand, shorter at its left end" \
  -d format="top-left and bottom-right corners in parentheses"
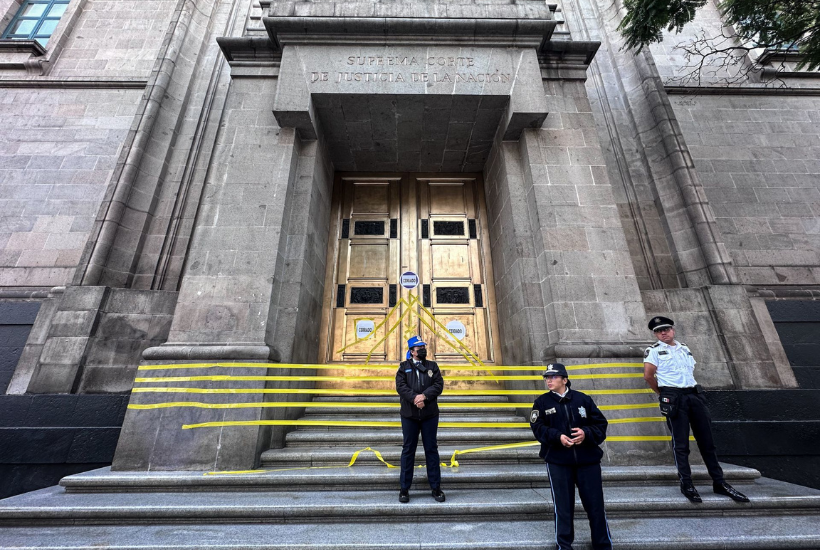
top-left (182, 416), bottom-right (665, 430)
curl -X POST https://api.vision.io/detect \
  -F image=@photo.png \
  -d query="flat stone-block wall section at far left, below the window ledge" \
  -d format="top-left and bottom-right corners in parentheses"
top-left (0, 87), bottom-right (141, 288)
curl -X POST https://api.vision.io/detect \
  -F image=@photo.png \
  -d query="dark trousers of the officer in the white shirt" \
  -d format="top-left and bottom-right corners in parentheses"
top-left (660, 388), bottom-right (724, 483)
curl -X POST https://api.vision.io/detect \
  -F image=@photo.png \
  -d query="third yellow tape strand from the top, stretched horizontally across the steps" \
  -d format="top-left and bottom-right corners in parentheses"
top-left (131, 387), bottom-right (654, 396)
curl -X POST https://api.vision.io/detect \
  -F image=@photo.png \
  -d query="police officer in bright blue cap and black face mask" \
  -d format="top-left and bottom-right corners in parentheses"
top-left (396, 336), bottom-right (444, 502)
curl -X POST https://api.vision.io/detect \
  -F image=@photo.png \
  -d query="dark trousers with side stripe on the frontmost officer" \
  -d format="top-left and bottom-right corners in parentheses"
top-left (547, 463), bottom-right (612, 550)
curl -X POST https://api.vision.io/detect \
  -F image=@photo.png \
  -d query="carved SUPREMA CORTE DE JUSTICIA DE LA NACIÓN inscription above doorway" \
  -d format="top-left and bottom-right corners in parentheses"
top-left (310, 55), bottom-right (512, 83)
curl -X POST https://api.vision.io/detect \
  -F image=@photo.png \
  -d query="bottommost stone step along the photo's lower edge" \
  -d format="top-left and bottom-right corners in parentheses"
top-left (0, 516), bottom-right (820, 550)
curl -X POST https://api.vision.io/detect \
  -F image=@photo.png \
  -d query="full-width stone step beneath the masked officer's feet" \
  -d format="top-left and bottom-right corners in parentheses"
top-left (0, 475), bottom-right (820, 526)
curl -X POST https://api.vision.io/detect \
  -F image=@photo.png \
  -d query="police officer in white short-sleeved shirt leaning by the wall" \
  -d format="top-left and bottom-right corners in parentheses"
top-left (643, 317), bottom-right (749, 502)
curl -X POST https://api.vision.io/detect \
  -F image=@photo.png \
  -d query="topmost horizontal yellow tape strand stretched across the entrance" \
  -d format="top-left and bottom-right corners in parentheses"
top-left (137, 362), bottom-right (643, 372)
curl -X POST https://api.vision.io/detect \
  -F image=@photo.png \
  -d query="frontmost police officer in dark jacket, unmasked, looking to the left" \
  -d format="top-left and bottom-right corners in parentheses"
top-left (530, 363), bottom-right (612, 550)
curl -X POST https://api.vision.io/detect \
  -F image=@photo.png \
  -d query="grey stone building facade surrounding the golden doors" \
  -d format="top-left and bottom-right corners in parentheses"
top-left (0, 0), bottom-right (820, 498)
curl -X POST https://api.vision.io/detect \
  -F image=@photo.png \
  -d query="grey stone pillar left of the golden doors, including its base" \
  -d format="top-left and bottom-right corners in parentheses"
top-left (114, 55), bottom-right (333, 470)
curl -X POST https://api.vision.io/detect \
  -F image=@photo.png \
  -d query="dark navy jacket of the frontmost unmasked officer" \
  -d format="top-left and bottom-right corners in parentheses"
top-left (530, 390), bottom-right (608, 465)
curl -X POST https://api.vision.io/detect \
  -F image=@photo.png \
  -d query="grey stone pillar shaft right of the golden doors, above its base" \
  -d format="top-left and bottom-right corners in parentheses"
top-left (485, 77), bottom-right (648, 364)
